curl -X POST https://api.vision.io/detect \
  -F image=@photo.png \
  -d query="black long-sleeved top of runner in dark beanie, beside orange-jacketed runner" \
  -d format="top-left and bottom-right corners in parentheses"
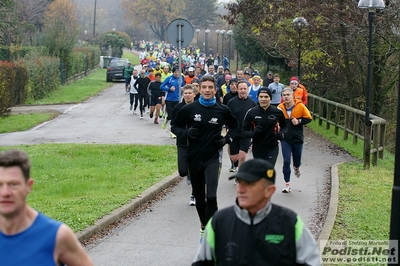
top-left (242, 105), bottom-right (287, 152)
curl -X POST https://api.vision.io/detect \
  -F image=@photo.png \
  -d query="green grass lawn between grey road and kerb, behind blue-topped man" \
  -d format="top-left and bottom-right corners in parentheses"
top-left (0, 144), bottom-right (177, 231)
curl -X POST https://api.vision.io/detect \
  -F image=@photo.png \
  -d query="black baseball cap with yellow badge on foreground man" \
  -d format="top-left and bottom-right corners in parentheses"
top-left (229, 159), bottom-right (275, 183)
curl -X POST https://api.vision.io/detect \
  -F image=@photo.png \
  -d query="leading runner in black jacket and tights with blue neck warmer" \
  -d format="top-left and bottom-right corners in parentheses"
top-left (171, 76), bottom-right (238, 241)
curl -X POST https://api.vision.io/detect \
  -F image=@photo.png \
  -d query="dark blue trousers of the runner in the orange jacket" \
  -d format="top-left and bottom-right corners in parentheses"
top-left (281, 140), bottom-right (303, 182)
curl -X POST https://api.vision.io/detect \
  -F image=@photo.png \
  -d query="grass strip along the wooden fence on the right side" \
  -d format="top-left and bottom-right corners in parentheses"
top-left (308, 121), bottom-right (394, 240)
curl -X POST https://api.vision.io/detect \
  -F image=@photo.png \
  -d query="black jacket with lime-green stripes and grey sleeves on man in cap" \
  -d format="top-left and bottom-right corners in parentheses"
top-left (192, 202), bottom-right (321, 266)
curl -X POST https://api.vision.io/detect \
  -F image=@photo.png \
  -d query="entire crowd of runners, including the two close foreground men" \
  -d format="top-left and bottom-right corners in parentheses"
top-left (0, 42), bottom-right (321, 266)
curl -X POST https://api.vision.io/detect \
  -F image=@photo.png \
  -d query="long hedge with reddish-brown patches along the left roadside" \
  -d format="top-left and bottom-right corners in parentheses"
top-left (0, 46), bottom-right (101, 102)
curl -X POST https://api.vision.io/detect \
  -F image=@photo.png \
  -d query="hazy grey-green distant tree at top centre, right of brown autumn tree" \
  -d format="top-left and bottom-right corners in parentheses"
top-left (183, 0), bottom-right (218, 27)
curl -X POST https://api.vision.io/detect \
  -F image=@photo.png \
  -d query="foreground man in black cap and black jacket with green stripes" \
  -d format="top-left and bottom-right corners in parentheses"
top-left (192, 159), bottom-right (321, 266)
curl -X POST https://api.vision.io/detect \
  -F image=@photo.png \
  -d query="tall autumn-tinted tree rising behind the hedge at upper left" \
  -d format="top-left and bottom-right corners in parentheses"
top-left (43, 0), bottom-right (79, 63)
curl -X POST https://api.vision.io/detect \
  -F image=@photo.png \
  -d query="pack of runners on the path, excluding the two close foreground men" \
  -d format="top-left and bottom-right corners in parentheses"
top-left (120, 43), bottom-right (320, 265)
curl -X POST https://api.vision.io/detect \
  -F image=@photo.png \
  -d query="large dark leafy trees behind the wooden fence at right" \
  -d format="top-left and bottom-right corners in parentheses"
top-left (224, 0), bottom-right (400, 119)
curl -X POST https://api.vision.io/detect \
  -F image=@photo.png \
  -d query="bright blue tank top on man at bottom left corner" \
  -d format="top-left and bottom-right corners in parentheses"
top-left (0, 213), bottom-right (61, 266)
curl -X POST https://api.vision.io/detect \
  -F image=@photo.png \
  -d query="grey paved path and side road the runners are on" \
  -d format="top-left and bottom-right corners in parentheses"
top-left (0, 79), bottom-right (348, 266)
